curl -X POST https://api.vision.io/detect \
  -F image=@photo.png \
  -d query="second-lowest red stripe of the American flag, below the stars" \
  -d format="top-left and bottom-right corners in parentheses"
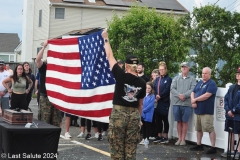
top-left (47, 90), bottom-right (113, 105)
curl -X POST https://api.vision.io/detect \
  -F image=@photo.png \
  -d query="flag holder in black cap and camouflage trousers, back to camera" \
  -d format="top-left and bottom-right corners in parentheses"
top-left (102, 30), bottom-right (146, 159)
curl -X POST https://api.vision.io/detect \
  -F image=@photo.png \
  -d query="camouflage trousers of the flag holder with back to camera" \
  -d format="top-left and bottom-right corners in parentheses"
top-left (108, 105), bottom-right (140, 160)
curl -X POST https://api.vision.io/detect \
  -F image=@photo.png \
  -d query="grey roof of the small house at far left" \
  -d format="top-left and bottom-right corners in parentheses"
top-left (0, 33), bottom-right (20, 52)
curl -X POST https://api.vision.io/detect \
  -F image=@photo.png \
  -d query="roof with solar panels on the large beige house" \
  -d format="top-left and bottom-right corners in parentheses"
top-left (49, 0), bottom-right (188, 12)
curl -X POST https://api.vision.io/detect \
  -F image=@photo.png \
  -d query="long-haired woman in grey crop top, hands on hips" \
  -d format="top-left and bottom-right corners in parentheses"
top-left (2, 64), bottom-right (33, 110)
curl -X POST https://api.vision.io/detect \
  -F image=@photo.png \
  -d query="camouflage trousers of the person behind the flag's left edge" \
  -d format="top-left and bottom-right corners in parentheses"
top-left (38, 96), bottom-right (62, 127)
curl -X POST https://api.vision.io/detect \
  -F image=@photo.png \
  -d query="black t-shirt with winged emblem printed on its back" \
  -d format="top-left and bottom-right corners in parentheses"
top-left (112, 63), bottom-right (146, 108)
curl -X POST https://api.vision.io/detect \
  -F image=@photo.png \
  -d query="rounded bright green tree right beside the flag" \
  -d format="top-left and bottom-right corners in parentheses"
top-left (108, 6), bottom-right (188, 75)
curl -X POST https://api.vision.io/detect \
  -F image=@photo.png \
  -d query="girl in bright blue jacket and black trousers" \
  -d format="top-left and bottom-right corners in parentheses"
top-left (140, 82), bottom-right (155, 145)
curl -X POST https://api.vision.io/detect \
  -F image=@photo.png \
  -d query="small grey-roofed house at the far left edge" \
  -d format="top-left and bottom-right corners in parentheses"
top-left (0, 33), bottom-right (20, 62)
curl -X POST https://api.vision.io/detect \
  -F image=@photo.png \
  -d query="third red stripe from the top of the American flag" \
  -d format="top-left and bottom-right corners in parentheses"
top-left (47, 64), bottom-right (82, 74)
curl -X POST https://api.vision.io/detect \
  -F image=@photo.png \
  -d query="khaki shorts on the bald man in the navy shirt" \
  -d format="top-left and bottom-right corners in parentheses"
top-left (195, 114), bottom-right (214, 133)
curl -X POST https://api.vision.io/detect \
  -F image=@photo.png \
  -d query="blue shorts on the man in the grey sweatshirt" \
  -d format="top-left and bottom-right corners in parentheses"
top-left (173, 105), bottom-right (192, 122)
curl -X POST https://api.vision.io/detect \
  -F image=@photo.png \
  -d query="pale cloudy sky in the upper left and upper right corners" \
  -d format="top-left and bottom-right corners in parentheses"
top-left (0, 0), bottom-right (240, 39)
